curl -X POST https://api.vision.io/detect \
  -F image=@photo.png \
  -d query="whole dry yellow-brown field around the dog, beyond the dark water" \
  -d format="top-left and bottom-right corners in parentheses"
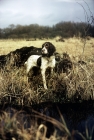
top-left (0, 37), bottom-right (94, 104)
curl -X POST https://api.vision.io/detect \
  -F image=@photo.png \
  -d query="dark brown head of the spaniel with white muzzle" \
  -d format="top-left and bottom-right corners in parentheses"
top-left (41, 42), bottom-right (56, 57)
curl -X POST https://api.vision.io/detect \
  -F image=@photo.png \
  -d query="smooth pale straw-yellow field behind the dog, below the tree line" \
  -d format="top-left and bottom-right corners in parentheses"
top-left (0, 37), bottom-right (94, 56)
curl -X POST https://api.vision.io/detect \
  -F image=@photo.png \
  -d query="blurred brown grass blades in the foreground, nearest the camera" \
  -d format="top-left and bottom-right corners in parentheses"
top-left (0, 108), bottom-right (93, 140)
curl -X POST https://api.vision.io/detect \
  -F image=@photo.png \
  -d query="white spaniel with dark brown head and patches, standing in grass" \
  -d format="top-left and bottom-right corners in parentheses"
top-left (25, 42), bottom-right (56, 89)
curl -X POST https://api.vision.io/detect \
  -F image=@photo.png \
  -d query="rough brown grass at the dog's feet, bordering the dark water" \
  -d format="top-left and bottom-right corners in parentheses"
top-left (0, 56), bottom-right (94, 106)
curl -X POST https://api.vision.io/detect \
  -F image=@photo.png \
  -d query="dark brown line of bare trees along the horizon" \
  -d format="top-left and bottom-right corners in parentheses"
top-left (0, 22), bottom-right (94, 40)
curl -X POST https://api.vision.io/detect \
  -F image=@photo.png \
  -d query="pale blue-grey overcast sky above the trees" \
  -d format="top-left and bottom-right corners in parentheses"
top-left (0, 0), bottom-right (94, 28)
